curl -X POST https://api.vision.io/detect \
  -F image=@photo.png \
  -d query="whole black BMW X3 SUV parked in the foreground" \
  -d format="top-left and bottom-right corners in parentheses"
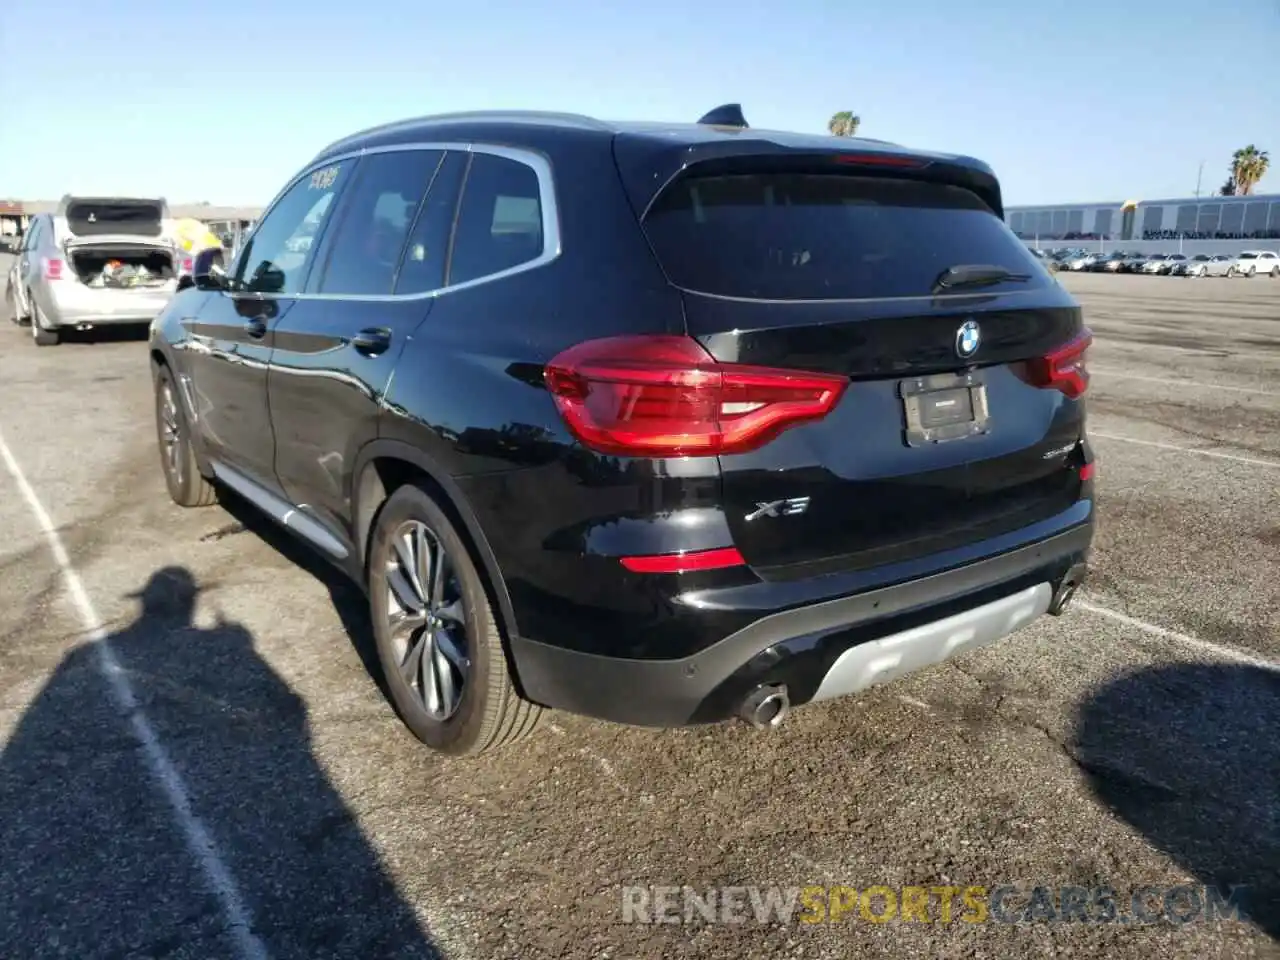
top-left (150, 106), bottom-right (1094, 754)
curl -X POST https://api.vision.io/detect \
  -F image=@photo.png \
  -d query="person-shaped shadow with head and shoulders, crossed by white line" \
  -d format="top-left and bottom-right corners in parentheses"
top-left (0, 567), bottom-right (439, 960)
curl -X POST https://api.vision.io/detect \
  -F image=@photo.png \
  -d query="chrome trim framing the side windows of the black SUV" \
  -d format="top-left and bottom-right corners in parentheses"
top-left (230, 141), bottom-right (562, 303)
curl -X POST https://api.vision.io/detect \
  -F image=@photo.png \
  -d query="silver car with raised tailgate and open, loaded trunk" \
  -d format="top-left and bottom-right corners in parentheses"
top-left (5, 196), bottom-right (182, 347)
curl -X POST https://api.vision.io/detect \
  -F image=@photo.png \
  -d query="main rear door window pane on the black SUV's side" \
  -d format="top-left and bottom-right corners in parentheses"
top-left (316, 150), bottom-right (443, 296)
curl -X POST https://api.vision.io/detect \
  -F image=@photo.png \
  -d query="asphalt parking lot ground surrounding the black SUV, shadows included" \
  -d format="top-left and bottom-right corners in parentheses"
top-left (0, 264), bottom-right (1280, 960)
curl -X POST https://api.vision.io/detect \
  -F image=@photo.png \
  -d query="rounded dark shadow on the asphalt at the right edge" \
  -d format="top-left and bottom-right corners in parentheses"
top-left (1075, 663), bottom-right (1280, 938)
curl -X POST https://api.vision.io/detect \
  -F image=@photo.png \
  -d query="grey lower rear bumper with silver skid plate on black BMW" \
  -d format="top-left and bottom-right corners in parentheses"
top-left (511, 513), bottom-right (1093, 727)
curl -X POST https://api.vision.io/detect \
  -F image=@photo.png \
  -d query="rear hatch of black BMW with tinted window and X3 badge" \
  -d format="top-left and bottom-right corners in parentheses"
top-left (620, 145), bottom-right (1088, 580)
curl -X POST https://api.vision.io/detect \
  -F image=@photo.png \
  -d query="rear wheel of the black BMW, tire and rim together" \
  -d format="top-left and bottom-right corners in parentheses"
top-left (367, 484), bottom-right (543, 755)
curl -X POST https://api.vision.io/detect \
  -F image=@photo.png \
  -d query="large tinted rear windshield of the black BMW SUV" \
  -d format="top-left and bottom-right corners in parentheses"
top-left (644, 173), bottom-right (1052, 300)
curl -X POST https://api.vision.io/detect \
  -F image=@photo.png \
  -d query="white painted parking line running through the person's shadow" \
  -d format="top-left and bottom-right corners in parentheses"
top-left (0, 434), bottom-right (269, 960)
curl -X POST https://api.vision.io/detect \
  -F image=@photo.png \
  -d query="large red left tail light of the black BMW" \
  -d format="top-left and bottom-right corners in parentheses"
top-left (544, 337), bottom-right (849, 457)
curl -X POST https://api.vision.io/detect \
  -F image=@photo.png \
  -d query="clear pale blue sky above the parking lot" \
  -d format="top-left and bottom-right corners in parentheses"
top-left (0, 0), bottom-right (1280, 204)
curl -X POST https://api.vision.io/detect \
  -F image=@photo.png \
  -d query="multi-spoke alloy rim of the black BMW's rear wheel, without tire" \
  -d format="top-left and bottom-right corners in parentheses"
top-left (385, 520), bottom-right (471, 721)
